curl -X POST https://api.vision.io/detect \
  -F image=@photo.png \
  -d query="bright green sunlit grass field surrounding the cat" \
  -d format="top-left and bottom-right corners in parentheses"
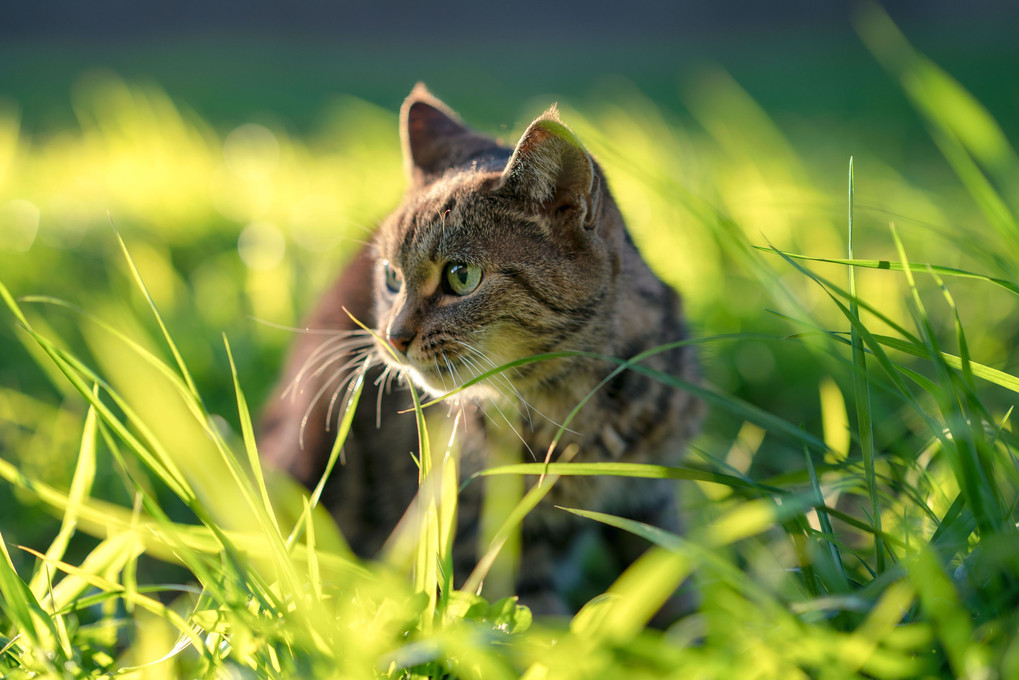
top-left (0, 6), bottom-right (1019, 680)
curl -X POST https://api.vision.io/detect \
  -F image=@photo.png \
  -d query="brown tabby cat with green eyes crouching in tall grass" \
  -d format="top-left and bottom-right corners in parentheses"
top-left (260, 84), bottom-right (703, 614)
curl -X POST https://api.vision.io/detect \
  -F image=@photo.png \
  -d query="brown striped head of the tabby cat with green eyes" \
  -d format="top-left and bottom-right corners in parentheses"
top-left (374, 86), bottom-right (623, 401)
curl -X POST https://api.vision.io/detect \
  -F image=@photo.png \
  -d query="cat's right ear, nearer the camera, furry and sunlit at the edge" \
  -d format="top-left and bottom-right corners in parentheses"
top-left (502, 104), bottom-right (600, 228)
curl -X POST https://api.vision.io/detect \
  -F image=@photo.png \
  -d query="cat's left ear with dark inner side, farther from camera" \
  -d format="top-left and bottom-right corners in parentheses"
top-left (399, 83), bottom-right (494, 187)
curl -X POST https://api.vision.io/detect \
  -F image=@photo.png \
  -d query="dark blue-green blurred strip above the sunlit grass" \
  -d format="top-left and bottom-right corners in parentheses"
top-left (0, 0), bottom-right (1019, 140)
